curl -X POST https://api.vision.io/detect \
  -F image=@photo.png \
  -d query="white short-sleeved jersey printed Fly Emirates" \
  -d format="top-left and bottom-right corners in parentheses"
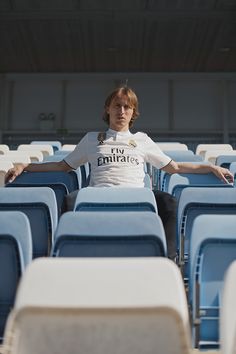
top-left (64, 129), bottom-right (171, 187)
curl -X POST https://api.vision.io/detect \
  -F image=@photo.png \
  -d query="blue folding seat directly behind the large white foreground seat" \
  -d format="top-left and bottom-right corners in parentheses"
top-left (52, 211), bottom-right (166, 257)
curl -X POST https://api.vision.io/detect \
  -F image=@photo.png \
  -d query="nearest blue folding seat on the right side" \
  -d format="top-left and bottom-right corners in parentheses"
top-left (188, 214), bottom-right (236, 350)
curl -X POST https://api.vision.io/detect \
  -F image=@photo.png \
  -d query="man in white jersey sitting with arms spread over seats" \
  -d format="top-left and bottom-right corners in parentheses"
top-left (6, 86), bottom-right (233, 259)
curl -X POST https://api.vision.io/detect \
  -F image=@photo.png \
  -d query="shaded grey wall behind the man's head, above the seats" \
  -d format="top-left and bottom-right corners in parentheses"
top-left (0, 73), bottom-right (236, 147)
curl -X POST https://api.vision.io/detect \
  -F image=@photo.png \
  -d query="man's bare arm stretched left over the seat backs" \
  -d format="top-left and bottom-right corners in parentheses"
top-left (5, 160), bottom-right (72, 183)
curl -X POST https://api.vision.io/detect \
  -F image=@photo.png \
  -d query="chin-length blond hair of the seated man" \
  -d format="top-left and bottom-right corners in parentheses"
top-left (103, 86), bottom-right (139, 127)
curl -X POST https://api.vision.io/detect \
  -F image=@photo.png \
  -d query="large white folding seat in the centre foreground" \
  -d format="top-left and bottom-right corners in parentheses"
top-left (4, 258), bottom-right (191, 354)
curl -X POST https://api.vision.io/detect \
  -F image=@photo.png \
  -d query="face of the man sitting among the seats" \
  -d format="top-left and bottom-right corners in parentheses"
top-left (107, 96), bottom-right (134, 131)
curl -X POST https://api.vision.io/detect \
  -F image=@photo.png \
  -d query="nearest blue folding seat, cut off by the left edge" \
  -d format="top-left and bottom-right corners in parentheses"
top-left (0, 211), bottom-right (32, 343)
